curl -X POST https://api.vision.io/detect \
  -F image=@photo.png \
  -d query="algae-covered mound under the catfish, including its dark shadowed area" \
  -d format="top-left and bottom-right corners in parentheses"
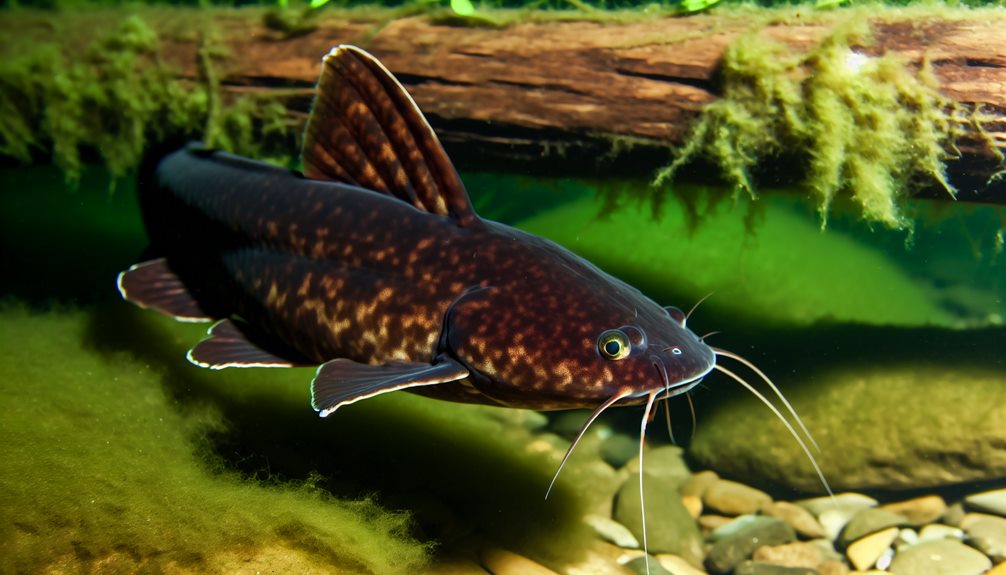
top-left (0, 303), bottom-right (599, 573)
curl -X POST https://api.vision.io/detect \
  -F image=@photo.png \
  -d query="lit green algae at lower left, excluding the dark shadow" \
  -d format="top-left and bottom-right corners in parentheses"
top-left (0, 308), bottom-right (429, 573)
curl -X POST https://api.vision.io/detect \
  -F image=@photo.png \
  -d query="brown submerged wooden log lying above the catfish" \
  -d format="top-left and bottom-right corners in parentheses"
top-left (3, 9), bottom-right (1006, 203)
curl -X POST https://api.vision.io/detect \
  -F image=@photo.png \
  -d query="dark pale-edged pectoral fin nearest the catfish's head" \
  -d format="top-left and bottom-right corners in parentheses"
top-left (311, 359), bottom-right (468, 417)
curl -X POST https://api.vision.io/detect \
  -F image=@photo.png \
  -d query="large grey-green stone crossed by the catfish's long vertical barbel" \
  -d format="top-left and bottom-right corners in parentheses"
top-left (614, 473), bottom-right (703, 565)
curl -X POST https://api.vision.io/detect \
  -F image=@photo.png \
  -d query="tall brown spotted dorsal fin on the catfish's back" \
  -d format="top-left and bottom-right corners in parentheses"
top-left (302, 45), bottom-right (476, 225)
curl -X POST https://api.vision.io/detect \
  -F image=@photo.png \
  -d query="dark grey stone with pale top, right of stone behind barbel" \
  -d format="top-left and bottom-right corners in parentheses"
top-left (705, 515), bottom-right (797, 573)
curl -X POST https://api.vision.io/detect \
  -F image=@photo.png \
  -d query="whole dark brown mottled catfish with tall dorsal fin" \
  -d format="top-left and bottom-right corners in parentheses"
top-left (119, 46), bottom-right (828, 570)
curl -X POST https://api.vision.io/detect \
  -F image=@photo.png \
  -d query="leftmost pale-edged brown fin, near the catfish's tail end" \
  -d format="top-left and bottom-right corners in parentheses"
top-left (119, 257), bottom-right (212, 322)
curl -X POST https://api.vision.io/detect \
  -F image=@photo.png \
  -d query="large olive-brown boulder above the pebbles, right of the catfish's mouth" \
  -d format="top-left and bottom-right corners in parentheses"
top-left (689, 359), bottom-right (1006, 492)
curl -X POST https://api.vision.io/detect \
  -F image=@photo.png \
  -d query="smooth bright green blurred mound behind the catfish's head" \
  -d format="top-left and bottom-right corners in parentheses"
top-left (517, 192), bottom-right (958, 326)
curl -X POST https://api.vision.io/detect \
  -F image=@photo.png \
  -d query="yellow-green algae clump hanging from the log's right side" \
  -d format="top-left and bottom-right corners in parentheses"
top-left (653, 19), bottom-right (967, 228)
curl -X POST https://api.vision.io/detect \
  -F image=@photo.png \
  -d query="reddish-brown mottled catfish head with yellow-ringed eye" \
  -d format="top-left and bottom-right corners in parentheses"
top-left (446, 267), bottom-right (715, 409)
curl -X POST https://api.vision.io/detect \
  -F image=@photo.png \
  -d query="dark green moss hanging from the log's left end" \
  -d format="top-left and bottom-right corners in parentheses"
top-left (0, 15), bottom-right (290, 185)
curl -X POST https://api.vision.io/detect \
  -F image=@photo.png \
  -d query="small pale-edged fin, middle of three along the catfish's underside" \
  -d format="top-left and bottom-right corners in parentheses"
top-left (186, 320), bottom-right (305, 369)
